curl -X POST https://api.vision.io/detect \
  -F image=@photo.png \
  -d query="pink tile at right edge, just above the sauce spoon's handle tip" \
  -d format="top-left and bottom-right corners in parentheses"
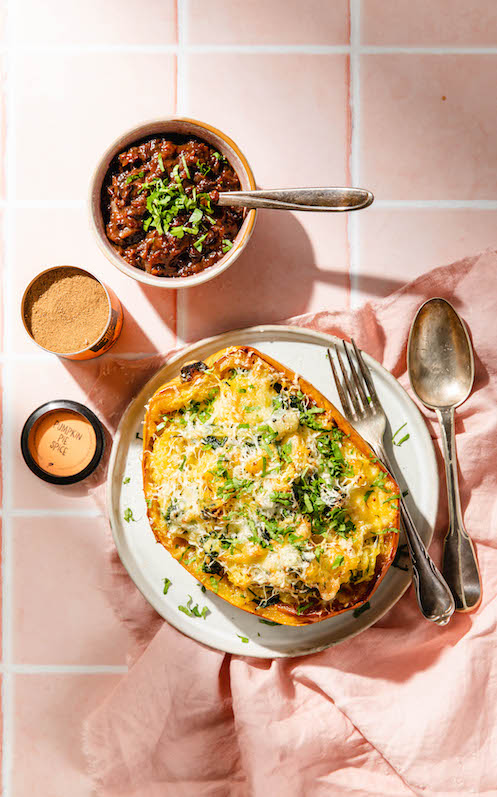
top-left (361, 55), bottom-right (497, 199)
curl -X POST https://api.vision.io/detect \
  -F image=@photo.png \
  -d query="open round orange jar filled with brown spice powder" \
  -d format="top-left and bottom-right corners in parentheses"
top-left (21, 266), bottom-right (123, 360)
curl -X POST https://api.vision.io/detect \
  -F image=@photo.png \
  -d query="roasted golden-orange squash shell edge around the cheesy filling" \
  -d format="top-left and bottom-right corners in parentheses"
top-left (143, 346), bottom-right (399, 626)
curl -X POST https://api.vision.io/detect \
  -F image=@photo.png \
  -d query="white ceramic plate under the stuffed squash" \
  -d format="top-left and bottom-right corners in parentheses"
top-left (107, 326), bottom-right (438, 658)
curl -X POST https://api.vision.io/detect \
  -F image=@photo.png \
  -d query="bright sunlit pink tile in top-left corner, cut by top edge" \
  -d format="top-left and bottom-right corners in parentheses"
top-left (13, 0), bottom-right (176, 45)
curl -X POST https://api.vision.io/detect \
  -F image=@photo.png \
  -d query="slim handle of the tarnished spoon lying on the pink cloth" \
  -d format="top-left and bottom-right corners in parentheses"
top-left (436, 407), bottom-right (481, 612)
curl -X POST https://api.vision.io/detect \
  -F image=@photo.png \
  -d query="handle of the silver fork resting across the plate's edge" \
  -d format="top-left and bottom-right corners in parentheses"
top-left (373, 445), bottom-right (455, 625)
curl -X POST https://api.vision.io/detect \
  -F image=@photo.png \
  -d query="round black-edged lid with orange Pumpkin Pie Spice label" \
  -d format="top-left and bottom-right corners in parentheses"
top-left (21, 399), bottom-right (105, 484)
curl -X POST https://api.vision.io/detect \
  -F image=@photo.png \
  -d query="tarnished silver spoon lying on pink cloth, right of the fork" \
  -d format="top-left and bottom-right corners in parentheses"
top-left (407, 298), bottom-right (481, 612)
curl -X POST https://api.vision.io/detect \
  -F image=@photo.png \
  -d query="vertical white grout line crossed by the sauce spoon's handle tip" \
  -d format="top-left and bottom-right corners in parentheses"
top-left (347, 0), bottom-right (364, 309)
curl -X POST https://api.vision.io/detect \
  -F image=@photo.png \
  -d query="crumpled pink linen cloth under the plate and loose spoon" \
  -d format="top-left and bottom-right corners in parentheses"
top-left (85, 252), bottom-right (497, 797)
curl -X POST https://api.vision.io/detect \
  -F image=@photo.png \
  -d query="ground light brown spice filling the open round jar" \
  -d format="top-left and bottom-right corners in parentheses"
top-left (24, 266), bottom-right (109, 354)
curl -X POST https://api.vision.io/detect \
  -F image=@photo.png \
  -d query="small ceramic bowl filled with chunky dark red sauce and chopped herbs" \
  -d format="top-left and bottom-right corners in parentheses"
top-left (90, 117), bottom-right (256, 288)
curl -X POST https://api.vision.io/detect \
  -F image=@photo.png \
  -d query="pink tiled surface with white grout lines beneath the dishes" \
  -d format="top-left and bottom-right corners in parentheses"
top-left (0, 0), bottom-right (497, 797)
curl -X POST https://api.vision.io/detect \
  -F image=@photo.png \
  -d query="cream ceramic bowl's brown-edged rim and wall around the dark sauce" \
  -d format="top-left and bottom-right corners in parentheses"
top-left (89, 116), bottom-right (256, 289)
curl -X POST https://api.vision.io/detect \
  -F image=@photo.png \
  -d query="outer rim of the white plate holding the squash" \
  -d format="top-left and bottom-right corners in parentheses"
top-left (107, 325), bottom-right (439, 658)
